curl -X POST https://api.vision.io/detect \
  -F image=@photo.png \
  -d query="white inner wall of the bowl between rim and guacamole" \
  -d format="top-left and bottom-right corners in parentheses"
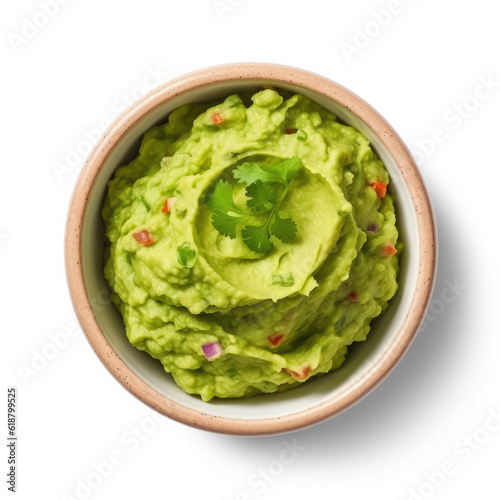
top-left (82, 81), bottom-right (419, 419)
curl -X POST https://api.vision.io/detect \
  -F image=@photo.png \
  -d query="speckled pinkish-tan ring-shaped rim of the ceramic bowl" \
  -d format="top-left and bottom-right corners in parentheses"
top-left (65, 63), bottom-right (437, 436)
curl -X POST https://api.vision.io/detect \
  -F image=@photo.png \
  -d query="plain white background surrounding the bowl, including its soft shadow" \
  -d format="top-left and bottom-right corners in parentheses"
top-left (0, 0), bottom-right (500, 500)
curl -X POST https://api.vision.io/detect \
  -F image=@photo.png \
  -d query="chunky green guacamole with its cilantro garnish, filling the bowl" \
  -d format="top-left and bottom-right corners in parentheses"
top-left (103, 89), bottom-right (401, 401)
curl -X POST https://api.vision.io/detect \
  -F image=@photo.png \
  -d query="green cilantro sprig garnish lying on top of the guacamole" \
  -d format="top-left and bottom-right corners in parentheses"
top-left (207, 157), bottom-right (304, 253)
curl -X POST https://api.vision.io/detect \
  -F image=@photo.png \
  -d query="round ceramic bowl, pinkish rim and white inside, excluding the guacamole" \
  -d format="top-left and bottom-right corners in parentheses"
top-left (65, 64), bottom-right (436, 435)
